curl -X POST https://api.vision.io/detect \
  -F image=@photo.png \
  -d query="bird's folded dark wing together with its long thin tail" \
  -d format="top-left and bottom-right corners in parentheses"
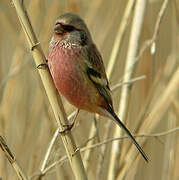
top-left (81, 45), bottom-right (148, 162)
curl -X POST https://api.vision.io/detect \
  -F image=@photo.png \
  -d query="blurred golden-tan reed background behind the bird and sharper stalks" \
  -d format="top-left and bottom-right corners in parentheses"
top-left (0, 0), bottom-right (179, 180)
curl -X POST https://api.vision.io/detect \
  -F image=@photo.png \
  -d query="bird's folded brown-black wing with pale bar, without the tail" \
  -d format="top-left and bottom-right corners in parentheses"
top-left (84, 44), bottom-right (112, 106)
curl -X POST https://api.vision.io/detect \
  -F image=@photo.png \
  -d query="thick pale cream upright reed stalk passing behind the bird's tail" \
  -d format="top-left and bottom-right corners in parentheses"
top-left (108, 0), bottom-right (147, 180)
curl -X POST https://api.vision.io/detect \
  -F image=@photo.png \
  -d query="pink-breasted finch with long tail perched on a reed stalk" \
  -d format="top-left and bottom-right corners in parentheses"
top-left (48, 13), bottom-right (148, 162)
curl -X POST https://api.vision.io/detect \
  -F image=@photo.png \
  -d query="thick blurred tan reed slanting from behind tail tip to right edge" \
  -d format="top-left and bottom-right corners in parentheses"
top-left (118, 68), bottom-right (179, 180)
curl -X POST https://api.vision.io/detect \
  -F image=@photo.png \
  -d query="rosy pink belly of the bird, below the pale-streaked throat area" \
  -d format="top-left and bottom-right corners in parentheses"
top-left (49, 48), bottom-right (98, 110)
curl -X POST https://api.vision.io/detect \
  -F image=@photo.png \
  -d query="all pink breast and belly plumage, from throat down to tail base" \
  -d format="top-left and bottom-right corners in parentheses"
top-left (48, 37), bottom-right (101, 114)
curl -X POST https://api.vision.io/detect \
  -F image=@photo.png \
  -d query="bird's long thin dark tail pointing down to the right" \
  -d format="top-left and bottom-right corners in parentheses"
top-left (107, 108), bottom-right (149, 162)
